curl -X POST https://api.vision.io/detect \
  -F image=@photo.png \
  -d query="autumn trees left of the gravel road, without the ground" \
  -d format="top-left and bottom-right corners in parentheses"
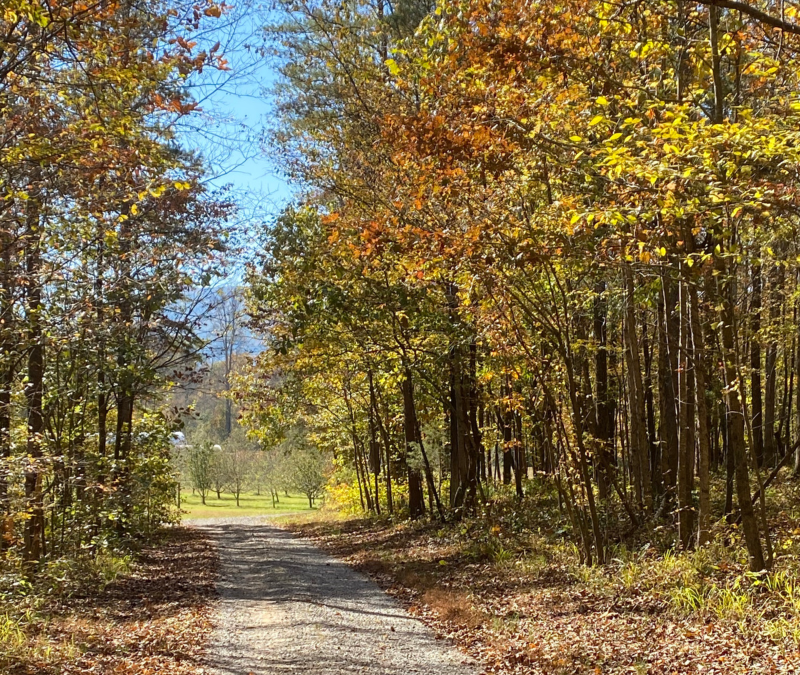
top-left (0, 0), bottom-right (232, 578)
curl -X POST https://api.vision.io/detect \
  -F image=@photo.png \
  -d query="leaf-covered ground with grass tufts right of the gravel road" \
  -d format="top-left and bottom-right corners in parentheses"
top-left (283, 494), bottom-right (800, 675)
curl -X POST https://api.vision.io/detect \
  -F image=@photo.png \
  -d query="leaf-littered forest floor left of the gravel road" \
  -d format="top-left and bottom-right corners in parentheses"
top-left (0, 527), bottom-right (217, 675)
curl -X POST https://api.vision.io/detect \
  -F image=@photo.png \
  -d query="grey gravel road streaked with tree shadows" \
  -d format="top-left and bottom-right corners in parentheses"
top-left (190, 517), bottom-right (481, 675)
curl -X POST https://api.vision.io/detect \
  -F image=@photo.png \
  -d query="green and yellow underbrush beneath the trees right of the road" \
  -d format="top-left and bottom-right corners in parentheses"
top-left (466, 481), bottom-right (800, 647)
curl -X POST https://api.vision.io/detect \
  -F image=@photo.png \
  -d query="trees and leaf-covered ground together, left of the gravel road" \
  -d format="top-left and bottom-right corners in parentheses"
top-left (0, 0), bottom-right (236, 675)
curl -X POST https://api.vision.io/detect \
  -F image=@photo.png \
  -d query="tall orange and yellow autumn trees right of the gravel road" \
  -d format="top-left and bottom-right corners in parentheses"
top-left (237, 0), bottom-right (800, 572)
